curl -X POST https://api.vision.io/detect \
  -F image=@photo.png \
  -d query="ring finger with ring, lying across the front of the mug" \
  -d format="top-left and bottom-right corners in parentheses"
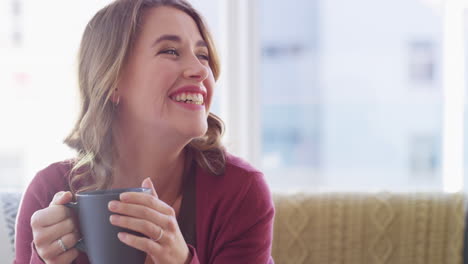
top-left (110, 215), bottom-right (167, 243)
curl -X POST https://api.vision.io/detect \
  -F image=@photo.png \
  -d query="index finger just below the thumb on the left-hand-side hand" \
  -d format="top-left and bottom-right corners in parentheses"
top-left (31, 205), bottom-right (70, 228)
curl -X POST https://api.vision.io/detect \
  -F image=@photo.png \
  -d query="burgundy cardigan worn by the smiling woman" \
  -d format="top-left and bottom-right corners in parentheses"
top-left (14, 154), bottom-right (274, 264)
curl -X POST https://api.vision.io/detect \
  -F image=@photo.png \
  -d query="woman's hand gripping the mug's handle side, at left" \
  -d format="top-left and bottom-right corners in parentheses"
top-left (31, 192), bottom-right (80, 264)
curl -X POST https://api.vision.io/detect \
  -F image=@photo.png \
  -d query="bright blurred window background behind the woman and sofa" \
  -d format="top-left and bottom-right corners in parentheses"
top-left (0, 0), bottom-right (468, 192)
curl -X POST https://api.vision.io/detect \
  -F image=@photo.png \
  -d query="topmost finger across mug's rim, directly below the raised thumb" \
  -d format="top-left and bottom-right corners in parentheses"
top-left (120, 192), bottom-right (175, 217)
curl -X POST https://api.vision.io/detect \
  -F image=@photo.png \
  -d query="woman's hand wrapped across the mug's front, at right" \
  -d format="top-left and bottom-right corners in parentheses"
top-left (109, 178), bottom-right (191, 264)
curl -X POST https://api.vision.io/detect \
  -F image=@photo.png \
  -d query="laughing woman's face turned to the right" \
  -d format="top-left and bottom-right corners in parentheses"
top-left (118, 6), bottom-right (214, 138)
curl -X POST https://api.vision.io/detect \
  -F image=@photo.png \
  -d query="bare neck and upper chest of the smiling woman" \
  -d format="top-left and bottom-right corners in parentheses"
top-left (112, 122), bottom-right (186, 205)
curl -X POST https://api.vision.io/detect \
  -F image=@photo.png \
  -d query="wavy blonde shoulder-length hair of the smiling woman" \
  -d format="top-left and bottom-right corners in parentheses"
top-left (65, 0), bottom-right (225, 194)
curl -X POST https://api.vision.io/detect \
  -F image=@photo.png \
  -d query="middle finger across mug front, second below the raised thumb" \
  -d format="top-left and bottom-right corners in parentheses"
top-left (109, 201), bottom-right (172, 229)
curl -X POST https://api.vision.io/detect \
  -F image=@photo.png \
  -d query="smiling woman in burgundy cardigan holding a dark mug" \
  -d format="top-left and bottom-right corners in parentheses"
top-left (15, 0), bottom-right (274, 264)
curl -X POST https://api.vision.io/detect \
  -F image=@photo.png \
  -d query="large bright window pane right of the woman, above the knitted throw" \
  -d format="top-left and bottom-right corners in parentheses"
top-left (259, 0), bottom-right (444, 191)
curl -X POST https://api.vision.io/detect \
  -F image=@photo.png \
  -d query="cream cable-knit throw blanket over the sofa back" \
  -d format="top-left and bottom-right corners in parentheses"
top-left (272, 193), bottom-right (464, 264)
